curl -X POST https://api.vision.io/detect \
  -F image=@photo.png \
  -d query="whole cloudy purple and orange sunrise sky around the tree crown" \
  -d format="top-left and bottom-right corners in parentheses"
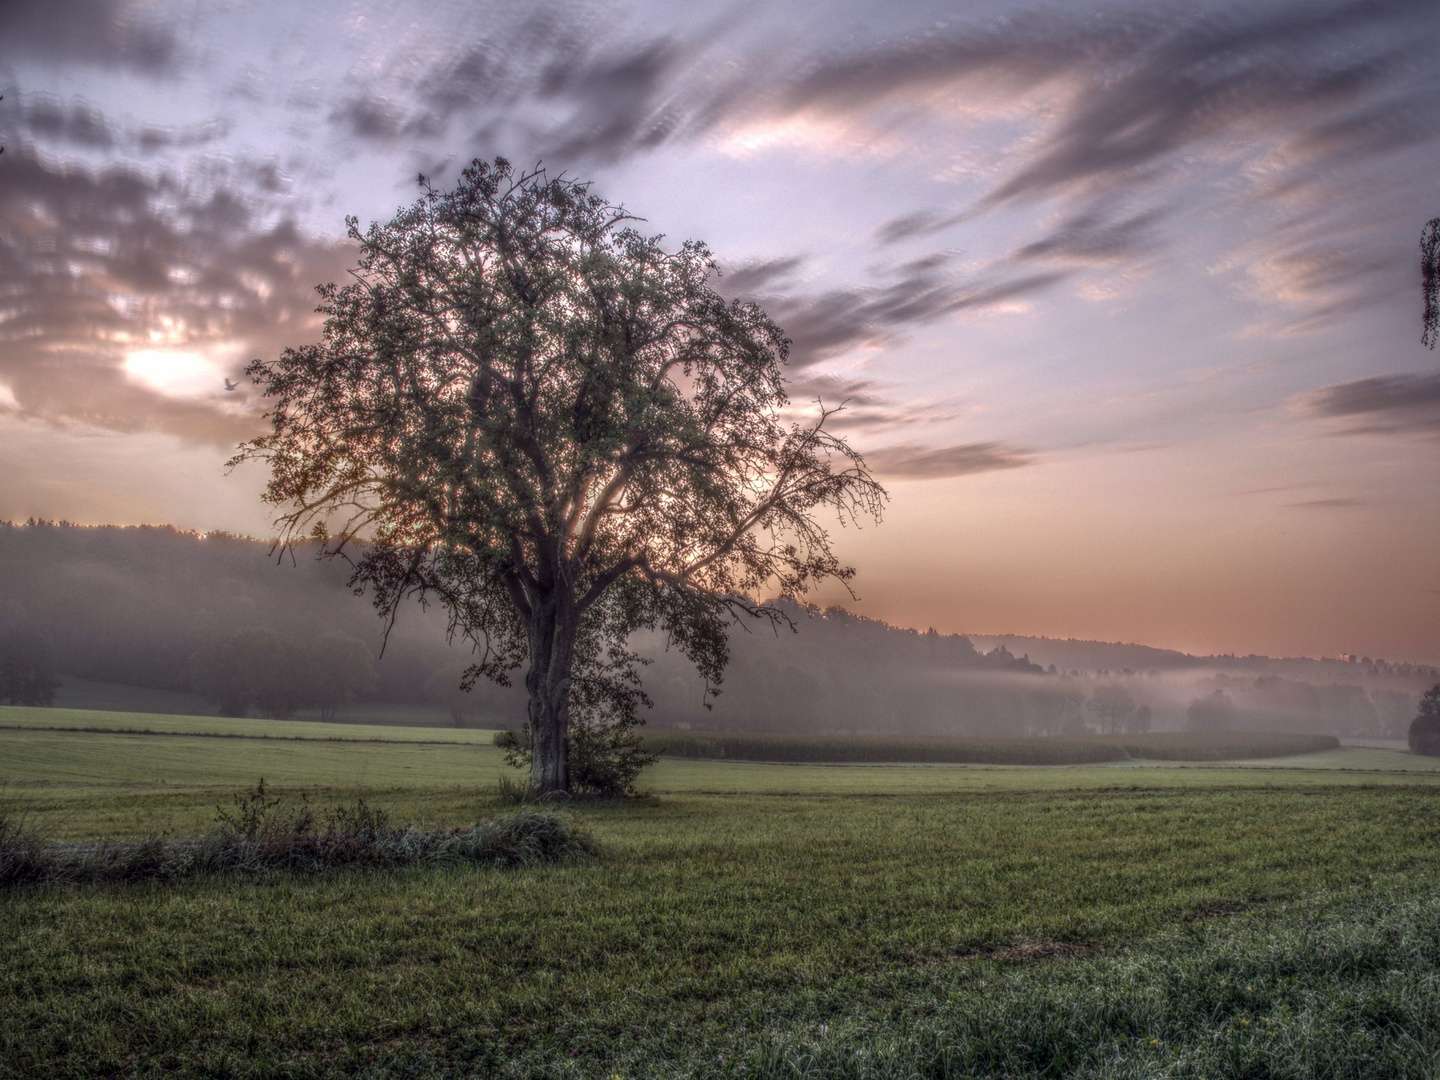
top-left (0, 0), bottom-right (1440, 662)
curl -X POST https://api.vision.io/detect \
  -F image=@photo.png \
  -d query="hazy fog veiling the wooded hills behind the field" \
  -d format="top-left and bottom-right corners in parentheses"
top-left (0, 524), bottom-right (1440, 739)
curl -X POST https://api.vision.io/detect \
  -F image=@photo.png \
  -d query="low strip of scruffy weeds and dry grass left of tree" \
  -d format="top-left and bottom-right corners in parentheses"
top-left (0, 780), bottom-right (598, 888)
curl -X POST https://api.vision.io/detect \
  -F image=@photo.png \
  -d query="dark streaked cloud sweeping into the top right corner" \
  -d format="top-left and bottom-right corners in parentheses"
top-left (765, 0), bottom-right (1440, 211)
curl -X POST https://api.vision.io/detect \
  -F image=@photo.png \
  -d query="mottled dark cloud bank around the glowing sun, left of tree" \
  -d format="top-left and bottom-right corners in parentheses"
top-left (0, 145), bottom-right (348, 445)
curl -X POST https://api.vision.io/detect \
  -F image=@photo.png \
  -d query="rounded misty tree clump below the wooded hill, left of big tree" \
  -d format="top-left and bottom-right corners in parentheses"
top-left (192, 626), bottom-right (377, 720)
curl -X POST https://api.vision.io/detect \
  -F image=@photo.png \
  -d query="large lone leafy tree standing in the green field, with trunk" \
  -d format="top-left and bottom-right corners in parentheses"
top-left (236, 158), bottom-right (886, 795)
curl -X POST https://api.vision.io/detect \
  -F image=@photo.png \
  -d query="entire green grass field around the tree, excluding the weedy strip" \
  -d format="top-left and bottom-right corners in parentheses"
top-left (8, 710), bottom-right (1440, 1080)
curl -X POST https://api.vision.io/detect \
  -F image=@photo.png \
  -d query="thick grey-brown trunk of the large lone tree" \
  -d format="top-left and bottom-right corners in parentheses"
top-left (526, 590), bottom-right (580, 795)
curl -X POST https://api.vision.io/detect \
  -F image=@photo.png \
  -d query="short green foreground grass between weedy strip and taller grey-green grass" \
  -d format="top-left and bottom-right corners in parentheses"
top-left (0, 788), bottom-right (1440, 1076)
